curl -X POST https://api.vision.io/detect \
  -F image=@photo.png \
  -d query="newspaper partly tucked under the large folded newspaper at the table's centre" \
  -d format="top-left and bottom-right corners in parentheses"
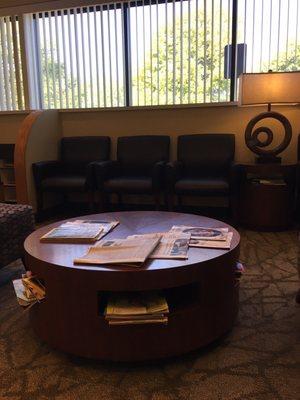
top-left (128, 231), bottom-right (191, 260)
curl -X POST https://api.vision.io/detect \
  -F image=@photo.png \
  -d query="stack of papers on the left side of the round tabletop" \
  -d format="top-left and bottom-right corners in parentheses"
top-left (40, 220), bottom-right (119, 243)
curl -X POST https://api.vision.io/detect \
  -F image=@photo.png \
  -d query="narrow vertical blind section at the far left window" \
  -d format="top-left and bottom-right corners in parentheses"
top-left (0, 16), bottom-right (24, 111)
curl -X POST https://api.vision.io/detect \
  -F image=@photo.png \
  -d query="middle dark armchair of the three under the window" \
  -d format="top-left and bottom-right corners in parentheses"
top-left (95, 135), bottom-right (170, 208)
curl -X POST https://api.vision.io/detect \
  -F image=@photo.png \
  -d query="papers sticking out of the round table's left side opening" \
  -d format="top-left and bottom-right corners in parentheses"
top-left (13, 272), bottom-right (45, 308)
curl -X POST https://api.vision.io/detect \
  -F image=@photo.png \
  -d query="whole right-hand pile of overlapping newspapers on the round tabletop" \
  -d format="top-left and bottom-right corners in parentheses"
top-left (170, 225), bottom-right (233, 250)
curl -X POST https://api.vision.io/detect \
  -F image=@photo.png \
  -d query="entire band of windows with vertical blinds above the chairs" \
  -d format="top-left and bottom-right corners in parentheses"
top-left (0, 0), bottom-right (300, 110)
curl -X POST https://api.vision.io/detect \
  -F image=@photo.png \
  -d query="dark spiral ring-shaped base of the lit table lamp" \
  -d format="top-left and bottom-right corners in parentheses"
top-left (245, 111), bottom-right (292, 158)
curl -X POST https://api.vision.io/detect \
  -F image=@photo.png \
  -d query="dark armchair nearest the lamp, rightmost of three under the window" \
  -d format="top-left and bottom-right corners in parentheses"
top-left (166, 133), bottom-right (235, 214)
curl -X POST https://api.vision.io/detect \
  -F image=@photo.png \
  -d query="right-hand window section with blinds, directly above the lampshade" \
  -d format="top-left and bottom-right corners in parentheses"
top-left (238, 0), bottom-right (300, 72)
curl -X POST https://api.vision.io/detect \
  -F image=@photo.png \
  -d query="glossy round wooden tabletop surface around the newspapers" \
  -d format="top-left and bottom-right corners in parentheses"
top-left (24, 211), bottom-right (240, 272)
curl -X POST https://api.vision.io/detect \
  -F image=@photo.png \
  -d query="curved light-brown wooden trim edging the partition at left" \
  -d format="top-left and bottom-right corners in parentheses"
top-left (14, 111), bottom-right (43, 204)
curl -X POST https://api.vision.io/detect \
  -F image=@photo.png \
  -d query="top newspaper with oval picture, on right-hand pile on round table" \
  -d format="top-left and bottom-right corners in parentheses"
top-left (170, 225), bottom-right (228, 241)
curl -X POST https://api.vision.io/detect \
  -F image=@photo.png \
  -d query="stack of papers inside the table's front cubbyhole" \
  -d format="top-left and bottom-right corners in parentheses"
top-left (104, 291), bottom-right (169, 325)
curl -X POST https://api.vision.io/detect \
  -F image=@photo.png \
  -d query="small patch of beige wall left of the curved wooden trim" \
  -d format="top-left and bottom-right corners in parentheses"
top-left (0, 112), bottom-right (28, 144)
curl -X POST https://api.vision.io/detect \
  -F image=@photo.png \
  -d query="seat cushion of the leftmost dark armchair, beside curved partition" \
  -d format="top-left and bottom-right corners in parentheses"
top-left (42, 175), bottom-right (86, 191)
